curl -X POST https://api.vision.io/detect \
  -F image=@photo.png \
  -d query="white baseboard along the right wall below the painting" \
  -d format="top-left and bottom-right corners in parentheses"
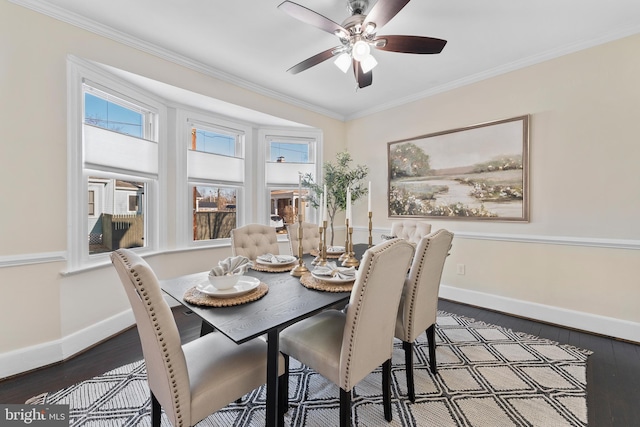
top-left (440, 285), bottom-right (640, 343)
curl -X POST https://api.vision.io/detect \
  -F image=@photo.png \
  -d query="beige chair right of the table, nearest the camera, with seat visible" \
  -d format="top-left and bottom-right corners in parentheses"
top-left (280, 239), bottom-right (414, 427)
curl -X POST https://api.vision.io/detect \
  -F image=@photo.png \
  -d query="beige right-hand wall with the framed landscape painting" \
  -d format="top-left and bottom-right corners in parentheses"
top-left (347, 36), bottom-right (640, 340)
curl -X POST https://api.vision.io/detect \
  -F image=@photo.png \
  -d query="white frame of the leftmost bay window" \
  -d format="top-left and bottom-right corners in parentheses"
top-left (67, 55), bottom-right (167, 272)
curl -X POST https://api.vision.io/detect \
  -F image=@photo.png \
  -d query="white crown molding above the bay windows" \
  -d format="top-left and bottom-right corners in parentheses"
top-left (9, 0), bottom-right (345, 121)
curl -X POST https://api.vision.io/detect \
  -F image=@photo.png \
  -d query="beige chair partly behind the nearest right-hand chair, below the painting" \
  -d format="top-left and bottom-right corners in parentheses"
top-left (395, 229), bottom-right (453, 402)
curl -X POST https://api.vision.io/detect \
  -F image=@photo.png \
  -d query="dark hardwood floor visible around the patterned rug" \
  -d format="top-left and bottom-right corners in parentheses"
top-left (0, 300), bottom-right (640, 427)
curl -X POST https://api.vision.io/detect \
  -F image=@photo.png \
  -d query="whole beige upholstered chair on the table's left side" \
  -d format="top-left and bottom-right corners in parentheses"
top-left (111, 249), bottom-right (286, 427)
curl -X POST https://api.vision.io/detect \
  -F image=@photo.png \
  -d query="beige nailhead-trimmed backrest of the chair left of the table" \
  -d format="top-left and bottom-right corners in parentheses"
top-left (111, 249), bottom-right (191, 426)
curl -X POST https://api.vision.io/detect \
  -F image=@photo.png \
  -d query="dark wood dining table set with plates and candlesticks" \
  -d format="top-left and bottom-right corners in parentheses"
top-left (160, 244), bottom-right (368, 427)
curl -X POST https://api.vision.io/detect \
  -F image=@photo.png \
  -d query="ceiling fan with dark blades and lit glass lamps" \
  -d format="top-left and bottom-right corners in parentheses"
top-left (278, 0), bottom-right (447, 88)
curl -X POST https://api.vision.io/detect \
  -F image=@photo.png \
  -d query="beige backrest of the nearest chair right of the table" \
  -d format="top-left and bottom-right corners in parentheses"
top-left (340, 239), bottom-right (414, 390)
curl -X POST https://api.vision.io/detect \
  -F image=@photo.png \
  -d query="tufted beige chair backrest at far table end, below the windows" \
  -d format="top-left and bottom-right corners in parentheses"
top-left (231, 224), bottom-right (280, 261)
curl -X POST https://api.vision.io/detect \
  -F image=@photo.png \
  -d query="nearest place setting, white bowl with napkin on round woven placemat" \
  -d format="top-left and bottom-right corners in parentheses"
top-left (184, 256), bottom-right (269, 307)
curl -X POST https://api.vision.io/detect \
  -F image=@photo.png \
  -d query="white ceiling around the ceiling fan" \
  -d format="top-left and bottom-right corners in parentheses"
top-left (17, 0), bottom-right (640, 119)
